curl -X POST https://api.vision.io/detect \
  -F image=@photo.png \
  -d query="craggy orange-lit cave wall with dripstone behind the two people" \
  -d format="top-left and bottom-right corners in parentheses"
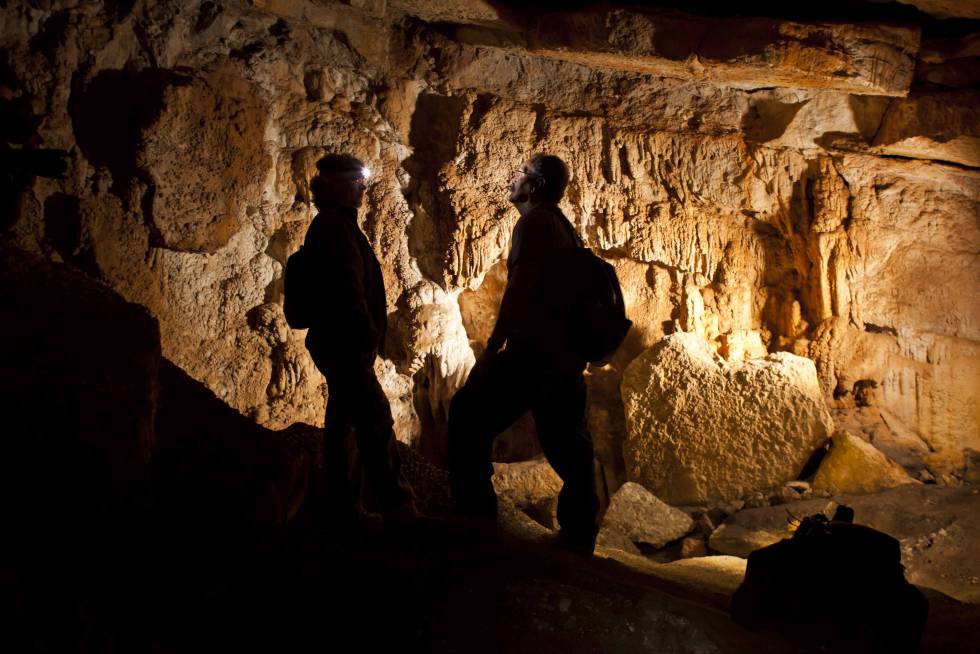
top-left (0, 0), bottom-right (980, 486)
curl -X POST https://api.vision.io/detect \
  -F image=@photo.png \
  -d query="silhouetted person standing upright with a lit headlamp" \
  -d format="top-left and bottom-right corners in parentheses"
top-left (304, 154), bottom-right (416, 520)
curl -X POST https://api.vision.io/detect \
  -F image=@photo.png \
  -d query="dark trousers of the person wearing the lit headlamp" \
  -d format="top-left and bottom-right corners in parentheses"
top-left (310, 348), bottom-right (411, 511)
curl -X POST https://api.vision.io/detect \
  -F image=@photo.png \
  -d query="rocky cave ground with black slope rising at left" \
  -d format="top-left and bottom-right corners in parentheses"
top-left (0, 250), bottom-right (980, 653)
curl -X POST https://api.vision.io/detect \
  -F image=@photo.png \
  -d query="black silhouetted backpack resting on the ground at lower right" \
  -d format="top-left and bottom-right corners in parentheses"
top-left (731, 506), bottom-right (929, 654)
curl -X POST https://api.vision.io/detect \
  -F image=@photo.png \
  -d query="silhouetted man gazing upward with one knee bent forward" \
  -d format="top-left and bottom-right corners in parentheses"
top-left (449, 153), bottom-right (599, 556)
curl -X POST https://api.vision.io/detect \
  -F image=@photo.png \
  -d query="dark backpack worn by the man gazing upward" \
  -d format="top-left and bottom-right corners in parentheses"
top-left (546, 216), bottom-right (633, 364)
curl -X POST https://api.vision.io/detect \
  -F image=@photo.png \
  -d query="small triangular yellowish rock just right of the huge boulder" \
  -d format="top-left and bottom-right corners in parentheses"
top-left (813, 431), bottom-right (917, 493)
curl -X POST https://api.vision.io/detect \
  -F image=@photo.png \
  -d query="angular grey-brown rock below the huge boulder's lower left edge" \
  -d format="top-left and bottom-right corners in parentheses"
top-left (599, 482), bottom-right (694, 548)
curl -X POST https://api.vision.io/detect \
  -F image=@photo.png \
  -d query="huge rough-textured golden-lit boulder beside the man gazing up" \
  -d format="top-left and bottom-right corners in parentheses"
top-left (622, 333), bottom-right (833, 504)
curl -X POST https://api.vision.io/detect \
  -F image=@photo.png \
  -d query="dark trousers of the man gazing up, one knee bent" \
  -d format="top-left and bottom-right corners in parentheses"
top-left (449, 346), bottom-right (599, 539)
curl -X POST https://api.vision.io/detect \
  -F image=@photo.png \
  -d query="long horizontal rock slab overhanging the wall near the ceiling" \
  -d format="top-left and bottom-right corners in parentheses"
top-left (457, 9), bottom-right (919, 95)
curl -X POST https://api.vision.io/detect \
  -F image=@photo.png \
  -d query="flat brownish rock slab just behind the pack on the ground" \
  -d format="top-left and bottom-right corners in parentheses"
top-left (710, 484), bottom-right (980, 603)
